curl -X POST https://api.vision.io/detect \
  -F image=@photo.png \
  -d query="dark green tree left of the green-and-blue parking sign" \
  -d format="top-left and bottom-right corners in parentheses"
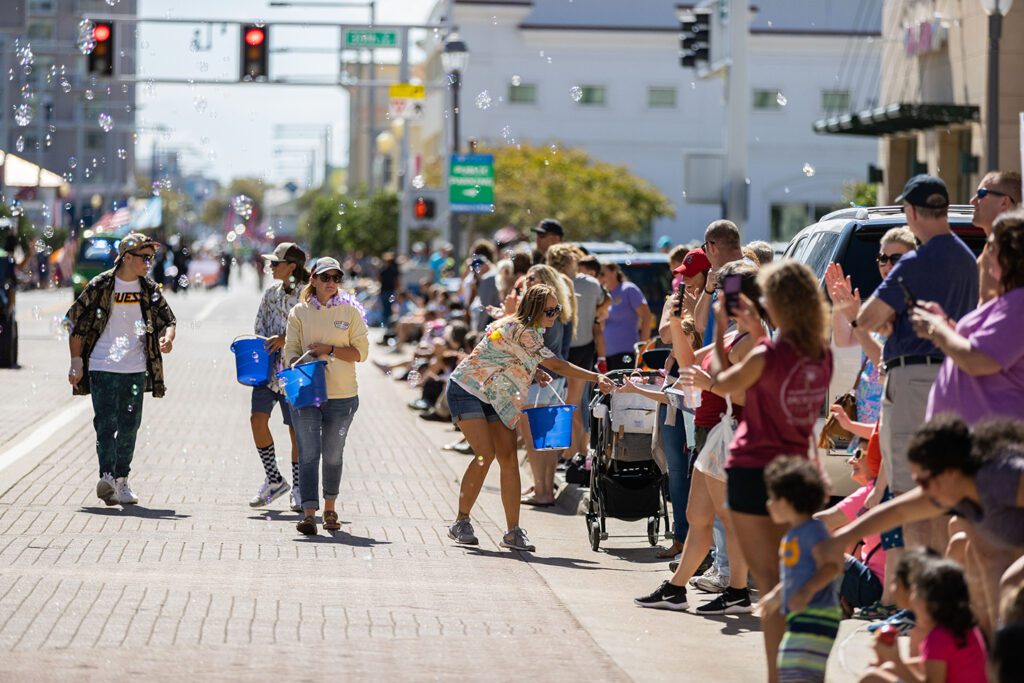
top-left (299, 190), bottom-right (398, 256)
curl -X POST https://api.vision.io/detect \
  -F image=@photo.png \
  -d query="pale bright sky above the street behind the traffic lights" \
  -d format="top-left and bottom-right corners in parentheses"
top-left (136, 0), bottom-right (435, 185)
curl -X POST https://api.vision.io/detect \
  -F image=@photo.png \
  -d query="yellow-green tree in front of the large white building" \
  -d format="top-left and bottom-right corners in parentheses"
top-left (475, 144), bottom-right (675, 240)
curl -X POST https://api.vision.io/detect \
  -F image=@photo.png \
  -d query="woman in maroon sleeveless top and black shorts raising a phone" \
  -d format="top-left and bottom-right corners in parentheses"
top-left (707, 261), bottom-right (842, 683)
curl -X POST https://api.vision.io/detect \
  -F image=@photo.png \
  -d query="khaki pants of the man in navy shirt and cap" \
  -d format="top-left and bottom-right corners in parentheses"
top-left (879, 364), bottom-right (939, 494)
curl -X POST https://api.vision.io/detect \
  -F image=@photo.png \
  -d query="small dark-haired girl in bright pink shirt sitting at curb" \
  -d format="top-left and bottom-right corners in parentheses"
top-left (860, 560), bottom-right (988, 683)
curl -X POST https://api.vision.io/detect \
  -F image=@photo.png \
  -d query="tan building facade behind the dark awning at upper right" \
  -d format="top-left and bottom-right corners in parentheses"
top-left (879, 0), bottom-right (1024, 204)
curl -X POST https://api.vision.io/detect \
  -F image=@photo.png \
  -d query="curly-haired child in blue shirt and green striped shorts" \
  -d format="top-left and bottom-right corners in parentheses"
top-left (760, 456), bottom-right (842, 683)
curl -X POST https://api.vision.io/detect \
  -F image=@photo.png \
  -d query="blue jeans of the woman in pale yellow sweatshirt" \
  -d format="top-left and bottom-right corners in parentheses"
top-left (292, 396), bottom-right (359, 510)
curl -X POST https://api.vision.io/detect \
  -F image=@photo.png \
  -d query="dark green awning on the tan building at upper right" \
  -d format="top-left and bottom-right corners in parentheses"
top-left (814, 103), bottom-right (981, 137)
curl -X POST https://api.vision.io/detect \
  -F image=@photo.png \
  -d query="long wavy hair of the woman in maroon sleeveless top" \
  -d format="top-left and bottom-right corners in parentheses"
top-left (758, 260), bottom-right (828, 360)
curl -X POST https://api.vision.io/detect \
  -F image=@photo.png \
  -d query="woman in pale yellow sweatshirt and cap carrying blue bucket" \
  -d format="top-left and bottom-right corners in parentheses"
top-left (285, 257), bottom-right (370, 536)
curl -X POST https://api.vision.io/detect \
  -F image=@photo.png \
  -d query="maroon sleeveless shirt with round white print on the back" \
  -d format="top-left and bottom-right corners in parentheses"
top-left (725, 337), bottom-right (833, 468)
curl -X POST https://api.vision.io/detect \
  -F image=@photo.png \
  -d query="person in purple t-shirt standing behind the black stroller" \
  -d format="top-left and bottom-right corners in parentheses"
top-left (601, 263), bottom-right (653, 370)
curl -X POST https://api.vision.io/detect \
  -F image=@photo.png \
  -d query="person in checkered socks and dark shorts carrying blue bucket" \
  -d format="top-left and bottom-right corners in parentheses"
top-left (249, 242), bottom-right (309, 512)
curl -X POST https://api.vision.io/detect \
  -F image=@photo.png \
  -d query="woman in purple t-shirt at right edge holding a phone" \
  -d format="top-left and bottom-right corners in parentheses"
top-left (911, 210), bottom-right (1024, 424)
